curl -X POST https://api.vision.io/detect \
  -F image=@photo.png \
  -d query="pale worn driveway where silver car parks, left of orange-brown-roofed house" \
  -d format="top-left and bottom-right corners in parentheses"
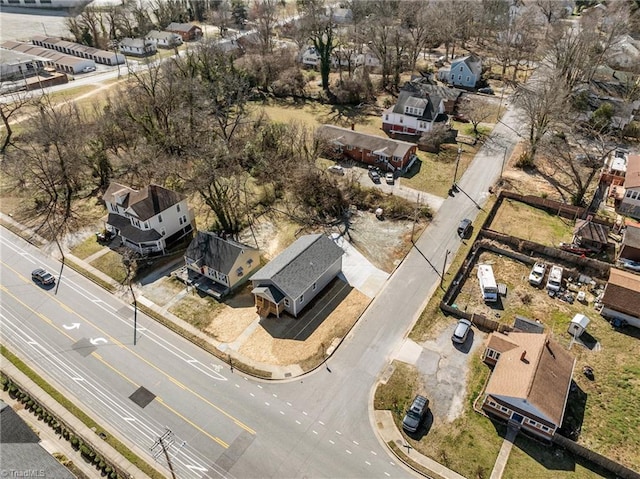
top-left (396, 319), bottom-right (485, 421)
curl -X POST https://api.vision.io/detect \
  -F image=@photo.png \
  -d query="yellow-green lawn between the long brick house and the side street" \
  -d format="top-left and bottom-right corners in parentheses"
top-left (400, 145), bottom-right (478, 198)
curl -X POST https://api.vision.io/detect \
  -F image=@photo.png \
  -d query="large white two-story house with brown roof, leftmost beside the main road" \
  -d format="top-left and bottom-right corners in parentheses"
top-left (102, 182), bottom-right (193, 254)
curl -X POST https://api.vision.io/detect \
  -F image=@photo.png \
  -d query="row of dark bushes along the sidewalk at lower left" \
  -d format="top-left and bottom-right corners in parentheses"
top-left (0, 373), bottom-right (129, 479)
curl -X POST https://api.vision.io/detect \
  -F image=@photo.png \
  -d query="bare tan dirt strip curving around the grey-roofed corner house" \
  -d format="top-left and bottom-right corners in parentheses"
top-left (239, 289), bottom-right (370, 370)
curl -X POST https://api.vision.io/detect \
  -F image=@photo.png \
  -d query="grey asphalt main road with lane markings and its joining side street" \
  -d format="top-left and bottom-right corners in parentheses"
top-left (0, 99), bottom-right (518, 478)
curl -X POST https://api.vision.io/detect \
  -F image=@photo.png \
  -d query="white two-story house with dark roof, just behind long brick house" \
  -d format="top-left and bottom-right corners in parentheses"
top-left (382, 89), bottom-right (447, 138)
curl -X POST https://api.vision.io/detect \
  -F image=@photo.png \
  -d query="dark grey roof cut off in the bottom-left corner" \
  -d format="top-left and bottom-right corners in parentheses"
top-left (0, 400), bottom-right (75, 479)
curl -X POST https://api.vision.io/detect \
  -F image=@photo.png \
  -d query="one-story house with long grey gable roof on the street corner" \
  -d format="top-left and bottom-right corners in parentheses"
top-left (251, 234), bottom-right (344, 317)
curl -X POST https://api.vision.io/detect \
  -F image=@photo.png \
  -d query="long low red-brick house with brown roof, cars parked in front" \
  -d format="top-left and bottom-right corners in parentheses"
top-left (316, 125), bottom-right (417, 171)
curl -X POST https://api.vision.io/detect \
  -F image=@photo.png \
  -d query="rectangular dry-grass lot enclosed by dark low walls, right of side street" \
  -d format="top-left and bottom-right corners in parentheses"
top-left (489, 199), bottom-right (574, 246)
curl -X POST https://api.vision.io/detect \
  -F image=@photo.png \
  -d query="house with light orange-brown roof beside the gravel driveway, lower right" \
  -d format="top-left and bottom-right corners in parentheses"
top-left (482, 332), bottom-right (575, 440)
